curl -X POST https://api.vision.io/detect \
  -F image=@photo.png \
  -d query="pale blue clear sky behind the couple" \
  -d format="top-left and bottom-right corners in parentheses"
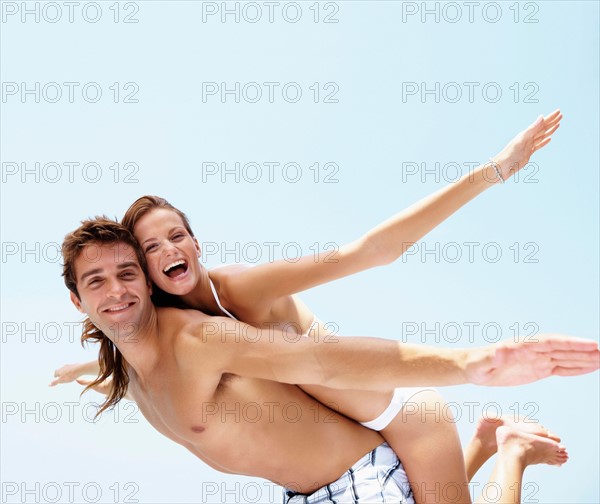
top-left (0, 1), bottom-right (600, 504)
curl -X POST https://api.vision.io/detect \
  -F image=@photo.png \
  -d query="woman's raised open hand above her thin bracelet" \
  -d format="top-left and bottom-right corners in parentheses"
top-left (492, 110), bottom-right (563, 180)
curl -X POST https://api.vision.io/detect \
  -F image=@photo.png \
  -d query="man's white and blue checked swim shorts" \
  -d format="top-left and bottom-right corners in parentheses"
top-left (283, 443), bottom-right (415, 504)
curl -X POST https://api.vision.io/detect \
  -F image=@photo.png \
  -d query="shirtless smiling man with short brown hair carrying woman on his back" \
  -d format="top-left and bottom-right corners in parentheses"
top-left (63, 219), bottom-right (599, 502)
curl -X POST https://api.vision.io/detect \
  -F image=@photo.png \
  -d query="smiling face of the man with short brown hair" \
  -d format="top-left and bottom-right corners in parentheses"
top-left (71, 242), bottom-right (152, 341)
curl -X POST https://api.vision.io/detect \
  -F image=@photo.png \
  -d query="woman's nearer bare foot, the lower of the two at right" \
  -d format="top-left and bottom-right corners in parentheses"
top-left (496, 426), bottom-right (569, 469)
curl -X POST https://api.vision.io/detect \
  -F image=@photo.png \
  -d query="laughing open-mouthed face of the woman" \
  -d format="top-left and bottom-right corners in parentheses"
top-left (133, 208), bottom-right (200, 296)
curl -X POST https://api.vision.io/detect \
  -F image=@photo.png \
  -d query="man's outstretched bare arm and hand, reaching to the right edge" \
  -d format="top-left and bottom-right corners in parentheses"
top-left (181, 317), bottom-right (600, 390)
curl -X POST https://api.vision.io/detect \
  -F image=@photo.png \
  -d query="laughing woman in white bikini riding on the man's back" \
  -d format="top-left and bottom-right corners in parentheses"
top-left (54, 111), bottom-right (566, 503)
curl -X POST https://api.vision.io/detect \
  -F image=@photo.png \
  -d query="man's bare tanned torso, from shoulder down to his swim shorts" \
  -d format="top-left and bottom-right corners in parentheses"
top-left (130, 309), bottom-right (383, 493)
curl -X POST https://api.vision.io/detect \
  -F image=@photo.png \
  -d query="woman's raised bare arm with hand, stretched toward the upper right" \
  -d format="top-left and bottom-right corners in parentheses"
top-left (226, 110), bottom-right (562, 306)
